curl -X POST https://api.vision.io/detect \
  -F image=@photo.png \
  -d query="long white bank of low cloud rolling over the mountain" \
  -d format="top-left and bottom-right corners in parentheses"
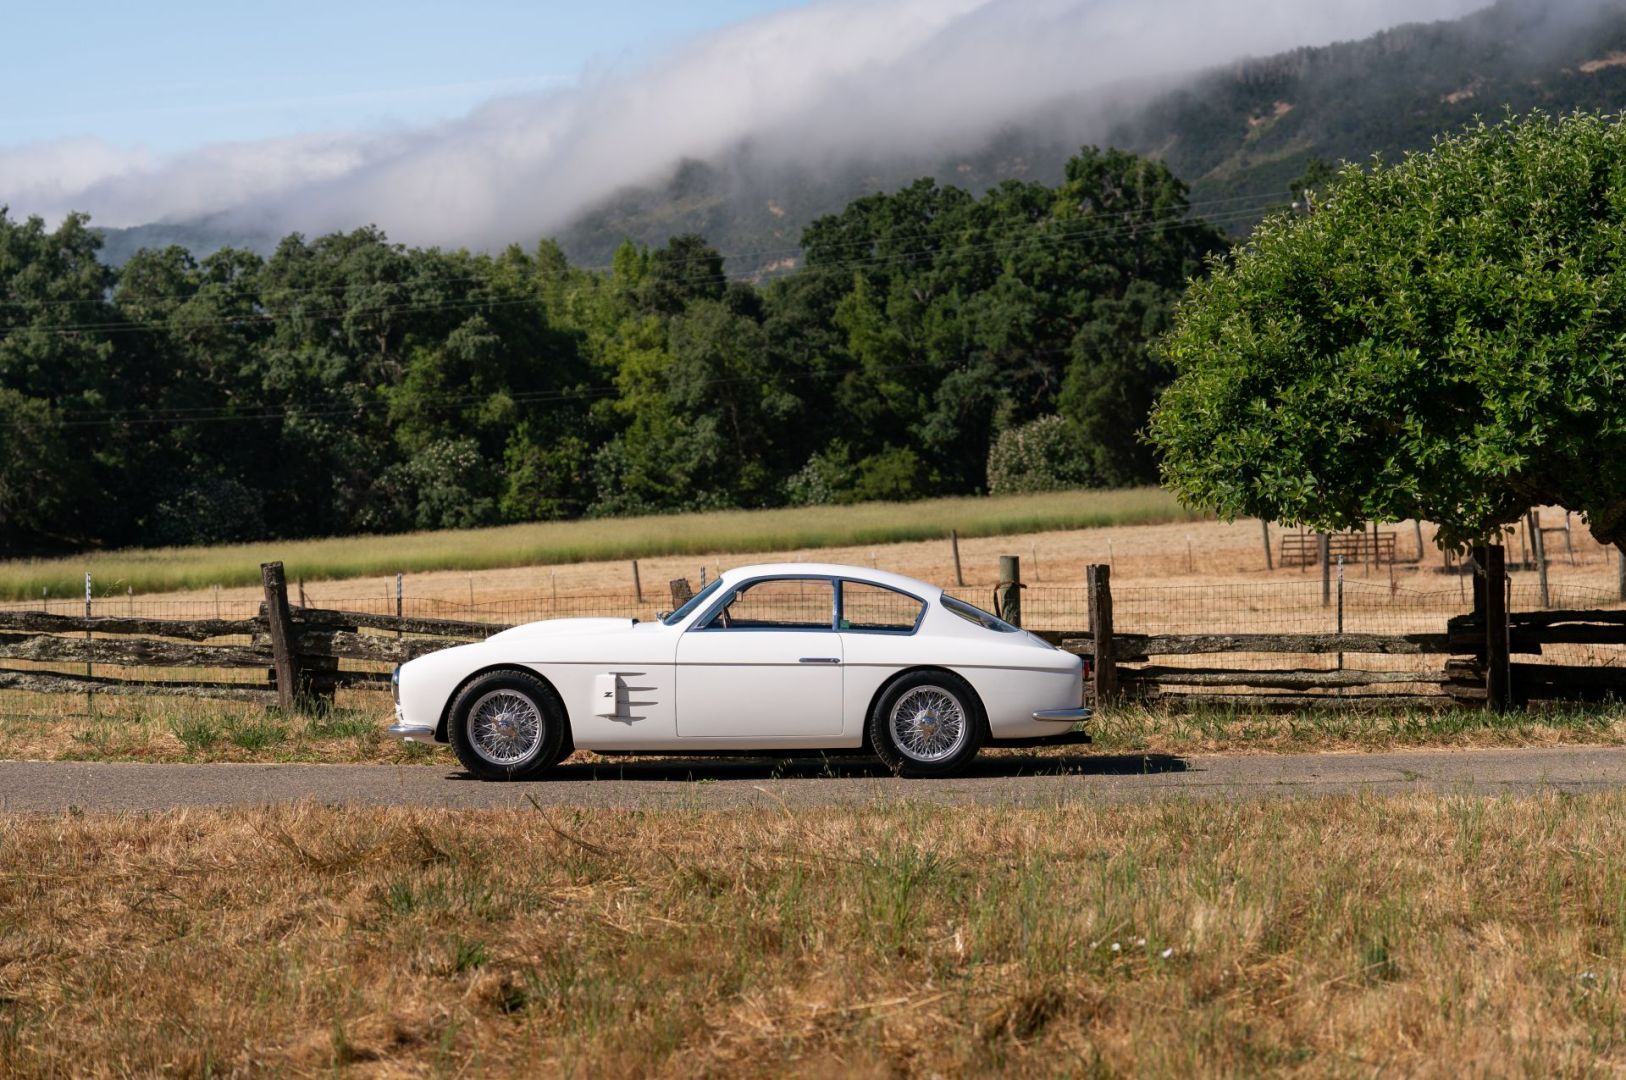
top-left (0, 0), bottom-right (1495, 247)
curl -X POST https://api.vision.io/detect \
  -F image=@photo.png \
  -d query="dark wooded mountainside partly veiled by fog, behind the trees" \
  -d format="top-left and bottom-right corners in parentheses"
top-left (95, 0), bottom-right (1626, 275)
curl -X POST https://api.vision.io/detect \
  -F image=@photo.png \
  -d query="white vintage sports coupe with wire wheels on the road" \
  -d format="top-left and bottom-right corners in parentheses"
top-left (390, 563), bottom-right (1089, 781)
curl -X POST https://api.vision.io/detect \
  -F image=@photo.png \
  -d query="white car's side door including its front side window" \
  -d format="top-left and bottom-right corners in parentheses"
top-left (676, 577), bottom-right (842, 742)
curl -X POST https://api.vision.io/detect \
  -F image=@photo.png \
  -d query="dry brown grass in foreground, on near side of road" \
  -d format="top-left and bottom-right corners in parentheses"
top-left (0, 794), bottom-right (1626, 1077)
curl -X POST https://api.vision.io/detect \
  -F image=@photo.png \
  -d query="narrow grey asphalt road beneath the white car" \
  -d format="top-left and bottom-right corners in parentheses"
top-left (0, 747), bottom-right (1626, 812)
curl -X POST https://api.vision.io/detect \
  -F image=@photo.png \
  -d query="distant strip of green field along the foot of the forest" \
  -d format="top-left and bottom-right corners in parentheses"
top-left (0, 488), bottom-right (1200, 600)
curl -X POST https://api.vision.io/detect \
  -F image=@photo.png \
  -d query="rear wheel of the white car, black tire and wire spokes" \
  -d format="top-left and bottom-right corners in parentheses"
top-left (870, 672), bottom-right (985, 776)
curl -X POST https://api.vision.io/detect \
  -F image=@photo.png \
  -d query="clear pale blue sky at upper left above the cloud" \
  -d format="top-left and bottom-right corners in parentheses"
top-left (0, 0), bottom-right (800, 151)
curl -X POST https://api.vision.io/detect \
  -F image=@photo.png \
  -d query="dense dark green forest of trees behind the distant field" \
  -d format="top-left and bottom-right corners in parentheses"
top-left (0, 150), bottom-right (1226, 556)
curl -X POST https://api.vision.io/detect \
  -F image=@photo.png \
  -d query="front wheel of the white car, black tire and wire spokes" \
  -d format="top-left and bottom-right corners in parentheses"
top-left (446, 672), bottom-right (571, 781)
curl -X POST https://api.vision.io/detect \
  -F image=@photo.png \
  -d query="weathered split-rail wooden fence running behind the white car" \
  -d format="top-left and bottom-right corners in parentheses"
top-left (0, 548), bottom-right (1626, 709)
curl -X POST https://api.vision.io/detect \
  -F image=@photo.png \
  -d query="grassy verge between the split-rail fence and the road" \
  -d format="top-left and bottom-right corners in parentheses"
top-left (0, 691), bottom-right (1626, 768)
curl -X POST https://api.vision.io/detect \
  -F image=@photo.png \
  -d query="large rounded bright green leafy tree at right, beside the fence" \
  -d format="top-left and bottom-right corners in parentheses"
top-left (1151, 114), bottom-right (1626, 547)
